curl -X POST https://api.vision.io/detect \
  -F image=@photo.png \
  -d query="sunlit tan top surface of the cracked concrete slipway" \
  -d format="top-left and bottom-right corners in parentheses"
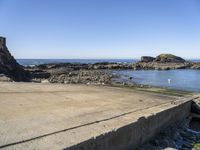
top-left (0, 82), bottom-right (189, 149)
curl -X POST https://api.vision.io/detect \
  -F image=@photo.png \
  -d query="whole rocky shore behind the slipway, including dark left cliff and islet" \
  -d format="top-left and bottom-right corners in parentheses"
top-left (0, 37), bottom-right (200, 85)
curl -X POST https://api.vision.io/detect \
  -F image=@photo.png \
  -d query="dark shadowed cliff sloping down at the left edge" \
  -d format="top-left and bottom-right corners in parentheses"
top-left (0, 37), bottom-right (28, 81)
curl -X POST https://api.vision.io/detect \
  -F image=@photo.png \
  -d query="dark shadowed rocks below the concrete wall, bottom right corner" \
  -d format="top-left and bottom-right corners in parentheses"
top-left (139, 99), bottom-right (200, 150)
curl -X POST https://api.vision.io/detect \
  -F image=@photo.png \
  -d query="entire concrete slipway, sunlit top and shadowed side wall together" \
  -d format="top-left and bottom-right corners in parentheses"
top-left (0, 83), bottom-right (195, 150)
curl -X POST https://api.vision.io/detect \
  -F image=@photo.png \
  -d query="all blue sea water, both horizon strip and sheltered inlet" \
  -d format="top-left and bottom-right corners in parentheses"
top-left (17, 59), bottom-right (200, 92)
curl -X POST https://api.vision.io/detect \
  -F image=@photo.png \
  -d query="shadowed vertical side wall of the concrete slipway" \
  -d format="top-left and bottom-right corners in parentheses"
top-left (66, 96), bottom-right (198, 150)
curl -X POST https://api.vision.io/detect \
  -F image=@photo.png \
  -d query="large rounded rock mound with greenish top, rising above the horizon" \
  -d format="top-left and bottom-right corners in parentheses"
top-left (155, 54), bottom-right (186, 63)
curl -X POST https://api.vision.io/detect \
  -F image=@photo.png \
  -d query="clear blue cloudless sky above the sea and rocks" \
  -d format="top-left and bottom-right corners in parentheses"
top-left (0, 0), bottom-right (200, 59)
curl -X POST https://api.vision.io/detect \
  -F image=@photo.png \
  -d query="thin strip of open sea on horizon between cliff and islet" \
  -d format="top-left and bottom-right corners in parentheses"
top-left (17, 59), bottom-right (138, 66)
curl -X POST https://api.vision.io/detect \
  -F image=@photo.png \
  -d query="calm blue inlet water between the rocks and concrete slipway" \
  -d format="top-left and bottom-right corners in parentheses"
top-left (118, 69), bottom-right (200, 92)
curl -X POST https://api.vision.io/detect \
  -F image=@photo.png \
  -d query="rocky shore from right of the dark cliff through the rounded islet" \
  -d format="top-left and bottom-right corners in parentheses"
top-left (24, 54), bottom-right (200, 85)
